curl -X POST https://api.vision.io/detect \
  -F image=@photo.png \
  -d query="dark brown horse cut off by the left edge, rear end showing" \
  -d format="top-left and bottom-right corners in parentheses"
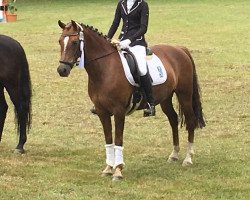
top-left (0, 35), bottom-right (32, 153)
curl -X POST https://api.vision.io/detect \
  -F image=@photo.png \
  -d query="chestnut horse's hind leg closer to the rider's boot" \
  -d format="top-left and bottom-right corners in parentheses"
top-left (161, 94), bottom-right (180, 162)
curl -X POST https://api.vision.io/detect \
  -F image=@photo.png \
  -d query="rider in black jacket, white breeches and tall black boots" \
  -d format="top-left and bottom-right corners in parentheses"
top-left (91, 0), bottom-right (155, 116)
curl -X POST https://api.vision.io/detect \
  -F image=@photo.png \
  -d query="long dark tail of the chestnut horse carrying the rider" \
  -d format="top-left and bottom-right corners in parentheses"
top-left (181, 47), bottom-right (206, 128)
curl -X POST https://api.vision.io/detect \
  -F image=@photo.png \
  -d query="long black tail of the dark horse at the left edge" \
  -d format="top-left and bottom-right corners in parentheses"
top-left (15, 48), bottom-right (32, 133)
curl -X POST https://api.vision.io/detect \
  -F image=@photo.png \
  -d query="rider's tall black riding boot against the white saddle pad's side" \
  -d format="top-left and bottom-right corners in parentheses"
top-left (140, 73), bottom-right (155, 117)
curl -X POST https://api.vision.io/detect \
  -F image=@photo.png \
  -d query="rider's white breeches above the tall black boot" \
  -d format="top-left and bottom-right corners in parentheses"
top-left (129, 45), bottom-right (147, 76)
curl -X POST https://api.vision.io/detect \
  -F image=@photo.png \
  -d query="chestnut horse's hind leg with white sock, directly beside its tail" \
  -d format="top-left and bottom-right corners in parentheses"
top-left (178, 95), bottom-right (195, 166)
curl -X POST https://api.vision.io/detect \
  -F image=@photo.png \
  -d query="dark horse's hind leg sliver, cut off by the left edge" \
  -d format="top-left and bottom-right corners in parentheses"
top-left (0, 86), bottom-right (8, 141)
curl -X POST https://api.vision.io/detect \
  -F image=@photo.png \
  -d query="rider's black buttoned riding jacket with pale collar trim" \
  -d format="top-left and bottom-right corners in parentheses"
top-left (108, 0), bottom-right (149, 47)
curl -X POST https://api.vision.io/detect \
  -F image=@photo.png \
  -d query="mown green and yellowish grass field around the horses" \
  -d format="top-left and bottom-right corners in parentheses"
top-left (0, 0), bottom-right (250, 200)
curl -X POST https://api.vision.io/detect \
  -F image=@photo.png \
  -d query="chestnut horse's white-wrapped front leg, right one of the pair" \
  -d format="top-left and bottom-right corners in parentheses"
top-left (113, 112), bottom-right (125, 180)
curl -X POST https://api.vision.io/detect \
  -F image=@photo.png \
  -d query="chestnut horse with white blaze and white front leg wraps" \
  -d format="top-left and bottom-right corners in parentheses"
top-left (57, 21), bottom-right (205, 180)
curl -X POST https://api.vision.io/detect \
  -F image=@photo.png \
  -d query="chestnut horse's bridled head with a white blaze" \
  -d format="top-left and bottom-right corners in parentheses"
top-left (57, 20), bottom-right (83, 77)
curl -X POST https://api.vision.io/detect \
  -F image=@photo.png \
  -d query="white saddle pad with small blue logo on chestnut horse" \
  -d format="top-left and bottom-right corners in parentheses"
top-left (119, 52), bottom-right (167, 87)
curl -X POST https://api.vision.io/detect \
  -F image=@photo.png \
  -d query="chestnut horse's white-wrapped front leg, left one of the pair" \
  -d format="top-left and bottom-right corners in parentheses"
top-left (98, 114), bottom-right (115, 176)
